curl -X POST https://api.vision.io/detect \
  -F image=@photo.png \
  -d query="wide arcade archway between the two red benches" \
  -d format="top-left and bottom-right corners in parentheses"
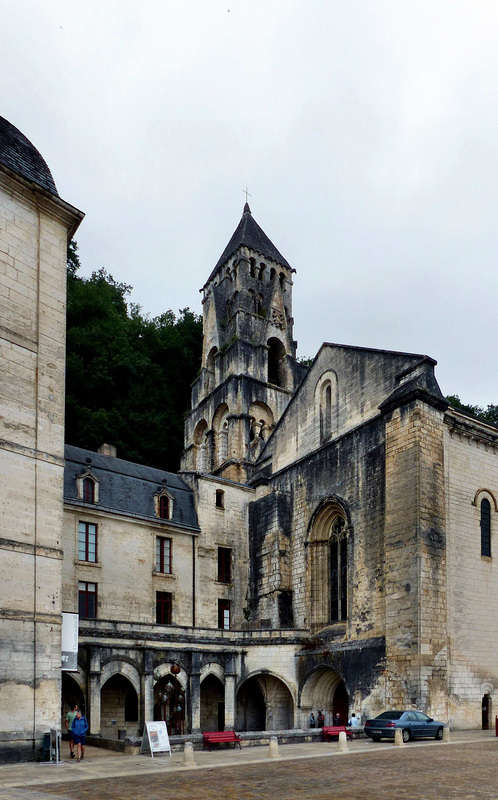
top-left (237, 673), bottom-right (294, 731)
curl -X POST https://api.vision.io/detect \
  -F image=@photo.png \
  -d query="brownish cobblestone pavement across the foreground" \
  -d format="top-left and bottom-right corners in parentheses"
top-left (0, 739), bottom-right (498, 800)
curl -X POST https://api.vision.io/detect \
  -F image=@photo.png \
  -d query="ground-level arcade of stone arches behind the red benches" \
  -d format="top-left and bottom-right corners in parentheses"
top-left (62, 661), bottom-right (354, 739)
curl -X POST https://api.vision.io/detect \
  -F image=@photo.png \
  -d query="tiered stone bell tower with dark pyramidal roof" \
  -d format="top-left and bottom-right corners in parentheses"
top-left (182, 203), bottom-right (303, 482)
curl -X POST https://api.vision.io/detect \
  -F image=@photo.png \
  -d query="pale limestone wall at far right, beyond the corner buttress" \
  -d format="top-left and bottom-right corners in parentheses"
top-left (445, 412), bottom-right (498, 728)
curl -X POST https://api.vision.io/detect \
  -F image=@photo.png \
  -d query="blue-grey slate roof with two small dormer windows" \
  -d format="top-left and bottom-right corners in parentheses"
top-left (64, 445), bottom-right (199, 530)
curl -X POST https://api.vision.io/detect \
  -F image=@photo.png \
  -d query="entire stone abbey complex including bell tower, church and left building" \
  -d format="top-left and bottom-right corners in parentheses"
top-left (0, 115), bottom-right (498, 757)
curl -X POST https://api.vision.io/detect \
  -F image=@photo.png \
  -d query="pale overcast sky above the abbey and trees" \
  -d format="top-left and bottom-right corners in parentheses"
top-left (0, 0), bottom-right (498, 405)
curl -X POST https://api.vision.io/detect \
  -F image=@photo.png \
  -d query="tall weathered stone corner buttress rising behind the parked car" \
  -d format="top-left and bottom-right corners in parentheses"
top-left (385, 401), bottom-right (448, 721)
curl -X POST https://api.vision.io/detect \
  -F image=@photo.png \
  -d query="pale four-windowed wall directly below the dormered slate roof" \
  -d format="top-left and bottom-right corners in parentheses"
top-left (63, 505), bottom-right (198, 625)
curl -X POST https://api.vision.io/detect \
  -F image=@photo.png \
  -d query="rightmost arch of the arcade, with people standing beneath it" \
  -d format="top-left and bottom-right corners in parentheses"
top-left (301, 667), bottom-right (349, 727)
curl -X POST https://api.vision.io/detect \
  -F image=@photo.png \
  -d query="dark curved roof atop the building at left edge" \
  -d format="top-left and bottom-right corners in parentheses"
top-left (0, 117), bottom-right (59, 197)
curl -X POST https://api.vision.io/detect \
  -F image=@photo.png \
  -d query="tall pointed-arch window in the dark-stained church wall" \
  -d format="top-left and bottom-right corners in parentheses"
top-left (308, 499), bottom-right (350, 631)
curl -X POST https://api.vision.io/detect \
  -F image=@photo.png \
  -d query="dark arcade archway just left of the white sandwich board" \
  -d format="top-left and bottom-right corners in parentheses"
top-left (100, 674), bottom-right (139, 739)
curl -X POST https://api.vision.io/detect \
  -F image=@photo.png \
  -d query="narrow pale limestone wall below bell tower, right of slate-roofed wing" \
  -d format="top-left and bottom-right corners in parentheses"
top-left (186, 475), bottom-right (254, 628)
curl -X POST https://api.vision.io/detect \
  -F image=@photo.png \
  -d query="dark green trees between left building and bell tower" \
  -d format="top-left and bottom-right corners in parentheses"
top-left (66, 243), bottom-right (202, 471)
